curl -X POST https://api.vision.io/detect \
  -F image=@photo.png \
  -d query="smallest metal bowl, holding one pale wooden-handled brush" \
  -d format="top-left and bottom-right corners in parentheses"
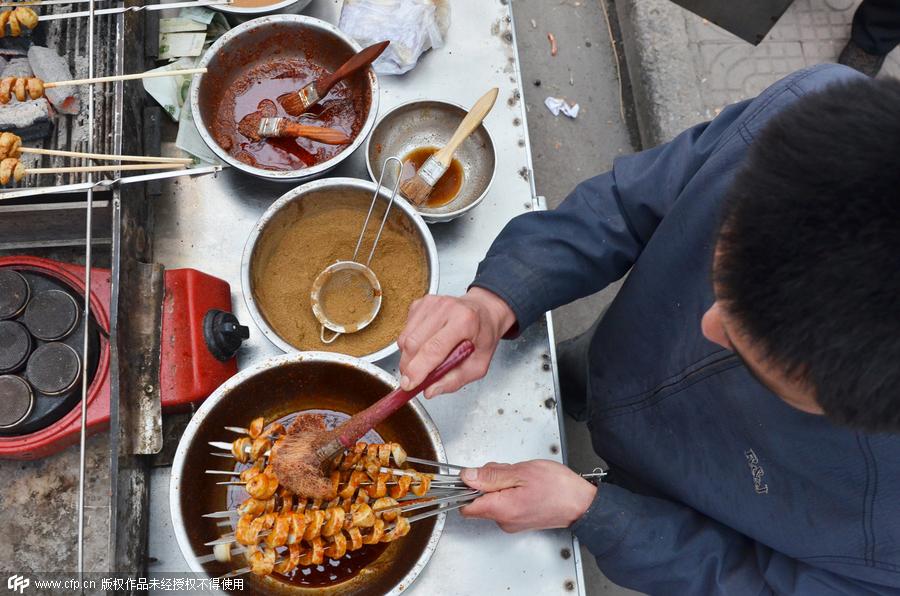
top-left (366, 100), bottom-right (497, 223)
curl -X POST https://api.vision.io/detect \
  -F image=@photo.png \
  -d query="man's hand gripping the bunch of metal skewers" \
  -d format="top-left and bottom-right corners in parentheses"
top-left (460, 459), bottom-right (597, 532)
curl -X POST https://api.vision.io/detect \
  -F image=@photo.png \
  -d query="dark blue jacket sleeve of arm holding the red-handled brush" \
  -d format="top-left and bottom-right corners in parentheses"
top-left (472, 96), bottom-right (748, 330)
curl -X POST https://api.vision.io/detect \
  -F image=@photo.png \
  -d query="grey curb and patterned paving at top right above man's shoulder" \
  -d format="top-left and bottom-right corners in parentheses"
top-left (616, 0), bottom-right (900, 147)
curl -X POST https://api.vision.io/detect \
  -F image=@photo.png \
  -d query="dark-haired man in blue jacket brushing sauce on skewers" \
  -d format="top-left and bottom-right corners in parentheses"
top-left (399, 65), bottom-right (900, 596)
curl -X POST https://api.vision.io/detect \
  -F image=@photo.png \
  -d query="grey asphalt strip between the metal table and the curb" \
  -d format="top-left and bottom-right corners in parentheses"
top-left (513, 0), bottom-right (637, 596)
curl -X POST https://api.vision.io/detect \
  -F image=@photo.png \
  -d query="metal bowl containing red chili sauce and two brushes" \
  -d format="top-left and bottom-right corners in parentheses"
top-left (190, 15), bottom-right (378, 183)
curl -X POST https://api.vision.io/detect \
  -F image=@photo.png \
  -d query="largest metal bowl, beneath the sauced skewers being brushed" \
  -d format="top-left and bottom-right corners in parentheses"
top-left (169, 352), bottom-right (446, 596)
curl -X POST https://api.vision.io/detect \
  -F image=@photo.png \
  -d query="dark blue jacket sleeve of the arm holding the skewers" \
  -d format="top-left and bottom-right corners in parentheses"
top-left (572, 484), bottom-right (900, 596)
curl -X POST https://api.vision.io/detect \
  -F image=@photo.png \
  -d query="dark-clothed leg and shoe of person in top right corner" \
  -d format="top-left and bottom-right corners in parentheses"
top-left (838, 0), bottom-right (900, 77)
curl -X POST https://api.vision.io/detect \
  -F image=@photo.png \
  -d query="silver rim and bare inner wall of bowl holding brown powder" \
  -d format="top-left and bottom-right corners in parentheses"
top-left (241, 178), bottom-right (439, 362)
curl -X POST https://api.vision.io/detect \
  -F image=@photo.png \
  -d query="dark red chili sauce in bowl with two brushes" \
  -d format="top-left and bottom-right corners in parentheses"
top-left (210, 56), bottom-right (368, 171)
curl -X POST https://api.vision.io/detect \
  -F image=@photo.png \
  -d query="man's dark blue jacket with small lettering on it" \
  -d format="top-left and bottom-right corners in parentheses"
top-left (474, 65), bottom-right (900, 596)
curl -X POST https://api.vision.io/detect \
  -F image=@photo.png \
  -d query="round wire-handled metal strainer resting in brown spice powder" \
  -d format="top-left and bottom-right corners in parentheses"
top-left (310, 157), bottom-right (403, 344)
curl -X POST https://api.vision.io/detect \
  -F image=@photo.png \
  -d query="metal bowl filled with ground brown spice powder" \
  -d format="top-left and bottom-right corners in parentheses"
top-left (241, 178), bottom-right (438, 362)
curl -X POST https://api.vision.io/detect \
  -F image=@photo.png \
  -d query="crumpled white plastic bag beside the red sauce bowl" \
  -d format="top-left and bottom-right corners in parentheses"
top-left (338, 0), bottom-right (450, 75)
